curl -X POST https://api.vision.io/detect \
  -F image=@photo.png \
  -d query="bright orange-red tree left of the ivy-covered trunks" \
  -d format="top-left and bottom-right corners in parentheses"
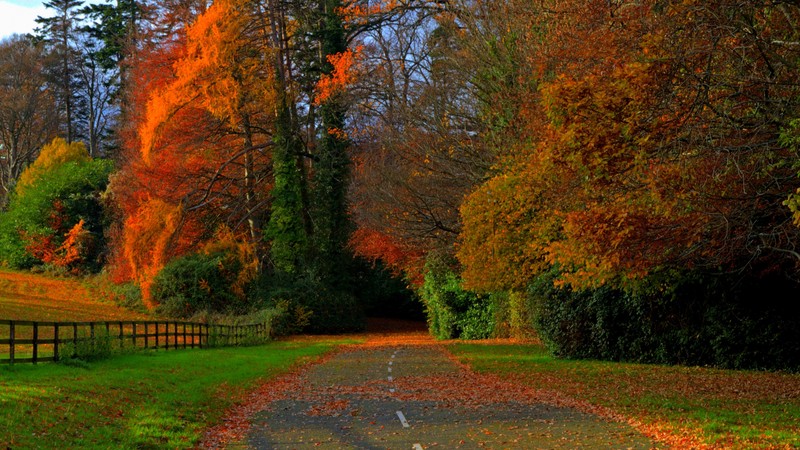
top-left (111, 0), bottom-right (274, 299)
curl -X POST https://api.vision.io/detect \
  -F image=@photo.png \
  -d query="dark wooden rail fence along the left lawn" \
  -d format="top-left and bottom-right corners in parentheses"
top-left (0, 320), bottom-right (269, 364)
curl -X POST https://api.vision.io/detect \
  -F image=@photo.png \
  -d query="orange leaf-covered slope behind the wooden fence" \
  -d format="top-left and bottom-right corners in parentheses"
top-left (0, 270), bottom-right (149, 322)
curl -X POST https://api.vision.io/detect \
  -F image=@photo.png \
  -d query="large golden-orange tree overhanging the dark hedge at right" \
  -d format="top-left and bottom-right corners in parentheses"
top-left (459, 0), bottom-right (800, 290)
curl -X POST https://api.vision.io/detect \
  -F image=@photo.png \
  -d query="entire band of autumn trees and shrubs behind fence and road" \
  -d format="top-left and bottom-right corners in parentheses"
top-left (0, 0), bottom-right (800, 367)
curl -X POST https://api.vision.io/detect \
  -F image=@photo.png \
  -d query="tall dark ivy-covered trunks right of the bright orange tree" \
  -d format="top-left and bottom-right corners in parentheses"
top-left (266, 0), bottom-right (365, 332)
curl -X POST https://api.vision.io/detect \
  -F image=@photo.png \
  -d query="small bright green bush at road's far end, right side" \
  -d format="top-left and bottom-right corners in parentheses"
top-left (420, 256), bottom-right (496, 339)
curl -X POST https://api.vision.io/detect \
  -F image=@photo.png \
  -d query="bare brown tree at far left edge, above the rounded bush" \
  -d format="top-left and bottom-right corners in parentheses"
top-left (0, 36), bottom-right (57, 205)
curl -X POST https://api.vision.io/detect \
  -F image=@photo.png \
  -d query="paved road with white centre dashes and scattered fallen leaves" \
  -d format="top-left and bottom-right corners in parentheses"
top-left (246, 342), bottom-right (657, 449)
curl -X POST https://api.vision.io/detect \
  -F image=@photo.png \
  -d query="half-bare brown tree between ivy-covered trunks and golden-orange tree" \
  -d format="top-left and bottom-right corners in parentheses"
top-left (352, 5), bottom-right (484, 280)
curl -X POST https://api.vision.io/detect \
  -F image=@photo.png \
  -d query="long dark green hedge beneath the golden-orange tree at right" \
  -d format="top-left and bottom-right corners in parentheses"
top-left (529, 270), bottom-right (800, 370)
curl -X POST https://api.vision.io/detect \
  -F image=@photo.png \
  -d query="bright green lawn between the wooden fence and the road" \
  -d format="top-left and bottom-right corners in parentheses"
top-left (0, 340), bottom-right (341, 448)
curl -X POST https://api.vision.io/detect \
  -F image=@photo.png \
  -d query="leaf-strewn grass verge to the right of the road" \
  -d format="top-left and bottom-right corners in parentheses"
top-left (449, 343), bottom-right (800, 449)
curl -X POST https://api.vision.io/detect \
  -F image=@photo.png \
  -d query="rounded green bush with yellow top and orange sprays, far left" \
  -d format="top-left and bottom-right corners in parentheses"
top-left (0, 141), bottom-right (113, 271)
